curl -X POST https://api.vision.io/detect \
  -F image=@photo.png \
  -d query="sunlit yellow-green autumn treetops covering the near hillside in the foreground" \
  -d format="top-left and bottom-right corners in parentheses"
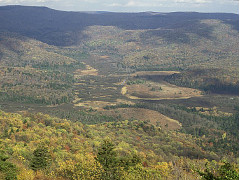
top-left (0, 111), bottom-right (238, 180)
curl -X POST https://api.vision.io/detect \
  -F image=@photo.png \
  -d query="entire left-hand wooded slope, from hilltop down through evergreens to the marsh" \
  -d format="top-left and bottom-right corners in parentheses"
top-left (0, 33), bottom-right (84, 104)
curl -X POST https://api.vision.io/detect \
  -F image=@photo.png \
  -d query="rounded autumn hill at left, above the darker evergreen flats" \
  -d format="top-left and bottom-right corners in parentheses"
top-left (0, 33), bottom-right (75, 67)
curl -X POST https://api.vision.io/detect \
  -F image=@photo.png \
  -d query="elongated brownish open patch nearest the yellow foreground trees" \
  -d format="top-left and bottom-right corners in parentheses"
top-left (103, 108), bottom-right (181, 130)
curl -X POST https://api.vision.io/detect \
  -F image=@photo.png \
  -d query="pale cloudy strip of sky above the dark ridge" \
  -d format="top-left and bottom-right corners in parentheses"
top-left (0, 0), bottom-right (239, 13)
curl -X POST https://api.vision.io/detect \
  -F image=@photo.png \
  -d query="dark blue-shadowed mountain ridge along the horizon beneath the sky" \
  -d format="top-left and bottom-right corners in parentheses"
top-left (0, 6), bottom-right (238, 46)
